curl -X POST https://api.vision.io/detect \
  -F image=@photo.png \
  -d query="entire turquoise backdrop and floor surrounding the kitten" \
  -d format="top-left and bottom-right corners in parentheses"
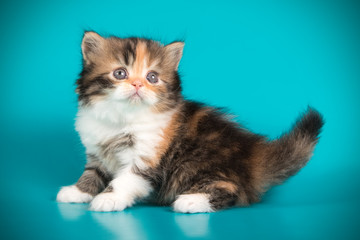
top-left (0, 0), bottom-right (360, 239)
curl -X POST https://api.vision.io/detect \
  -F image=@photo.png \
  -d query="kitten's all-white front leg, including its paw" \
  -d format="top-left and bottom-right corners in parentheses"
top-left (90, 170), bottom-right (152, 212)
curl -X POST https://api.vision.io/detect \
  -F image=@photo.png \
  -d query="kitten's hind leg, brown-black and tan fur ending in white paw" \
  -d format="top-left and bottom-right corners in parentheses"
top-left (173, 181), bottom-right (238, 213)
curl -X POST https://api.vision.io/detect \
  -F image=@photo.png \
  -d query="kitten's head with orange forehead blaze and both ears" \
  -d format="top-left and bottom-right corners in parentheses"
top-left (76, 32), bottom-right (184, 111)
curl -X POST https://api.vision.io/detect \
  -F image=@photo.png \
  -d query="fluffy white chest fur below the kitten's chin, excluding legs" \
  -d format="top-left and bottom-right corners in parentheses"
top-left (76, 102), bottom-right (174, 173)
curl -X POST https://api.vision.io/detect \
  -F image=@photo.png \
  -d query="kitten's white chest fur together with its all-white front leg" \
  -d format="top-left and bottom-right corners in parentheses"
top-left (76, 91), bottom-right (175, 211)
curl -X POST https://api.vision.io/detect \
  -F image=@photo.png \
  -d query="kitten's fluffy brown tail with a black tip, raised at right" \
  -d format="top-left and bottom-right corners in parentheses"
top-left (261, 107), bottom-right (324, 190)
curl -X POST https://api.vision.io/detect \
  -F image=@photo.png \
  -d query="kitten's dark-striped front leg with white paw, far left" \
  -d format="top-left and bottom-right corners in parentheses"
top-left (56, 162), bottom-right (111, 203)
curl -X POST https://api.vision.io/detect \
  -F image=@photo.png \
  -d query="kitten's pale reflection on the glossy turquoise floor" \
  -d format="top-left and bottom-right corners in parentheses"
top-left (58, 203), bottom-right (211, 239)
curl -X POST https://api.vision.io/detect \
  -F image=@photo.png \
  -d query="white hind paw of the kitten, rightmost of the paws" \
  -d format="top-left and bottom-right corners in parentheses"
top-left (173, 193), bottom-right (214, 213)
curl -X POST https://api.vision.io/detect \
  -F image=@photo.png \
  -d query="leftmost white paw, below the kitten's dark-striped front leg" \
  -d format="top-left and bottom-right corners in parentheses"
top-left (56, 185), bottom-right (93, 203)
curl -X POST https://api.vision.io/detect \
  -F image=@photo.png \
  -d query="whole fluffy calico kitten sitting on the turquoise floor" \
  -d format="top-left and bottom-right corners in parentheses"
top-left (57, 32), bottom-right (323, 213)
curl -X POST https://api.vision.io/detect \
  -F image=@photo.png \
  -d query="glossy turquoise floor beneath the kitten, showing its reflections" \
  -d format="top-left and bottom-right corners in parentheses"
top-left (1, 184), bottom-right (359, 240)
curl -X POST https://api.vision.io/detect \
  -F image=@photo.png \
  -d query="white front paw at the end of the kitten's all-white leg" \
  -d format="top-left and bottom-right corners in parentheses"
top-left (90, 192), bottom-right (129, 212)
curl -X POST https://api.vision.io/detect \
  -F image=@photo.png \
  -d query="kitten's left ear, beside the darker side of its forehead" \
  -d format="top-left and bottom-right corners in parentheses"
top-left (81, 32), bottom-right (105, 64)
